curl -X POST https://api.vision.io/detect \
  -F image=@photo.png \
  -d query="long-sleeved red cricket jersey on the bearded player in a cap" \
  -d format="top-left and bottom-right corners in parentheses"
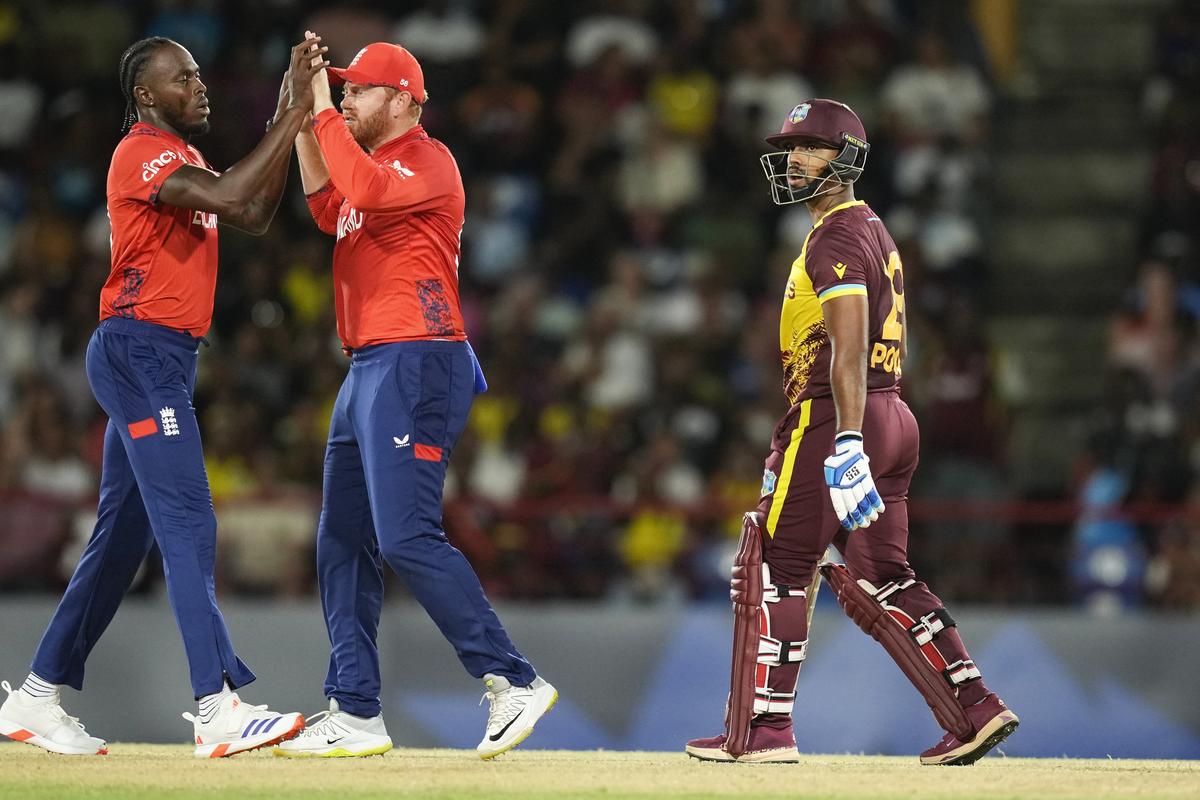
top-left (308, 109), bottom-right (467, 348)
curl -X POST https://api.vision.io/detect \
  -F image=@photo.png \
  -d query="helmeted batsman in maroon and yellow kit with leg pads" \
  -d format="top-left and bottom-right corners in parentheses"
top-left (685, 100), bottom-right (1018, 765)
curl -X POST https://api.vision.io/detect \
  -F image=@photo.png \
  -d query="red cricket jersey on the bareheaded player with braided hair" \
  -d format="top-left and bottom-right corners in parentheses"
top-left (100, 122), bottom-right (217, 336)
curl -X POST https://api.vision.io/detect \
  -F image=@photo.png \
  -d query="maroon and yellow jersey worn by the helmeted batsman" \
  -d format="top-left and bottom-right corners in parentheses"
top-left (779, 200), bottom-right (905, 404)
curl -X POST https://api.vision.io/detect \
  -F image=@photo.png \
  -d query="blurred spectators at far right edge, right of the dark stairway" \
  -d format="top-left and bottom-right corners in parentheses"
top-left (1072, 2), bottom-right (1200, 608)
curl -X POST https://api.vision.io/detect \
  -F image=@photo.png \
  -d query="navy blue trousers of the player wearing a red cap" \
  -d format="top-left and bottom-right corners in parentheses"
top-left (317, 341), bottom-right (536, 717)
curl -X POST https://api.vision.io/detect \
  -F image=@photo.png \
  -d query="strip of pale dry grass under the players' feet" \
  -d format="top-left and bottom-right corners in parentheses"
top-left (0, 742), bottom-right (1200, 800)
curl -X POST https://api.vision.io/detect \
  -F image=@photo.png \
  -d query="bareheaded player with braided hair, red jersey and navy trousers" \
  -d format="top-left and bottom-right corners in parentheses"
top-left (11, 36), bottom-right (326, 758)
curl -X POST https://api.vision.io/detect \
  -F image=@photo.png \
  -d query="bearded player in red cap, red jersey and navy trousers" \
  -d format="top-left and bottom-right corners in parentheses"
top-left (288, 42), bottom-right (558, 759)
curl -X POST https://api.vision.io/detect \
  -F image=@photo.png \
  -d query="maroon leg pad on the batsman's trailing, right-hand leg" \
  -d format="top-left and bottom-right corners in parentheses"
top-left (816, 564), bottom-right (974, 738)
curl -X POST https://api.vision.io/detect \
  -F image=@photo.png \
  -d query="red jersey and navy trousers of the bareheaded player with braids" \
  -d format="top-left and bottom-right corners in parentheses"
top-left (32, 122), bottom-right (254, 698)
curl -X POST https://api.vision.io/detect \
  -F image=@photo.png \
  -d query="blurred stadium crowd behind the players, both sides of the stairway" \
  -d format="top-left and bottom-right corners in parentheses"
top-left (0, 0), bottom-right (1200, 607)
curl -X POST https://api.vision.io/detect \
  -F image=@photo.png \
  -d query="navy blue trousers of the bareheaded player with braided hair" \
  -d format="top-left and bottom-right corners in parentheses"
top-left (31, 318), bottom-right (254, 698)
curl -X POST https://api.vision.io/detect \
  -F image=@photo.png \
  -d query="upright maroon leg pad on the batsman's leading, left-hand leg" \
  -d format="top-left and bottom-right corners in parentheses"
top-left (725, 511), bottom-right (763, 758)
